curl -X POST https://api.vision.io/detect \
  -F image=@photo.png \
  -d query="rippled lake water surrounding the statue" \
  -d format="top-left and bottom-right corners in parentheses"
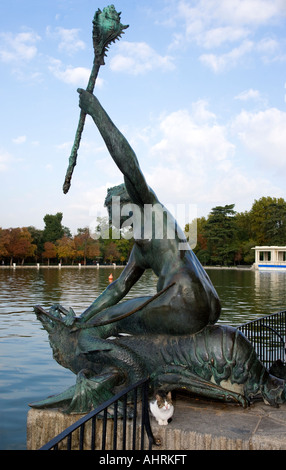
top-left (0, 267), bottom-right (286, 450)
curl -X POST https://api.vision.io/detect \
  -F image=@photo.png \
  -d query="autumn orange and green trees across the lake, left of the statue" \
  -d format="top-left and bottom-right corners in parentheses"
top-left (0, 212), bottom-right (133, 265)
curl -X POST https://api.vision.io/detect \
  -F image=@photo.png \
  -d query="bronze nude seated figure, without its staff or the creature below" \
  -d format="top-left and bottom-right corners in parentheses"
top-left (62, 90), bottom-right (220, 337)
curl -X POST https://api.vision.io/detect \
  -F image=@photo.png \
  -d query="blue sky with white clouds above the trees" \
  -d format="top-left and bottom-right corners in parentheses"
top-left (0, 0), bottom-right (286, 233)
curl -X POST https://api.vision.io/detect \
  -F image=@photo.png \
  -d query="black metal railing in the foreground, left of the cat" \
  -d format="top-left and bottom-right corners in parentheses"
top-left (39, 378), bottom-right (155, 450)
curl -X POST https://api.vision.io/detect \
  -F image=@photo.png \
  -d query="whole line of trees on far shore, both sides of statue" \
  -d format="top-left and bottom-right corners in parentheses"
top-left (0, 197), bottom-right (286, 266)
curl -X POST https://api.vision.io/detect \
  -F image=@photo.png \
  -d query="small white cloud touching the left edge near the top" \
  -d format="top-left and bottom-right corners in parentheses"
top-left (0, 31), bottom-right (41, 63)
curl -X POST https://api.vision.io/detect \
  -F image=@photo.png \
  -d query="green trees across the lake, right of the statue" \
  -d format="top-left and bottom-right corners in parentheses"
top-left (191, 197), bottom-right (286, 266)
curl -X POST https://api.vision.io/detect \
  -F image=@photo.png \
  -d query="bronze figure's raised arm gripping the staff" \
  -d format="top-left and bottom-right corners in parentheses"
top-left (78, 89), bottom-right (156, 206)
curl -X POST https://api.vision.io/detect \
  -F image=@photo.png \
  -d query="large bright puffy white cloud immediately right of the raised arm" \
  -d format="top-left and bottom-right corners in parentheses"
top-left (147, 101), bottom-right (235, 208)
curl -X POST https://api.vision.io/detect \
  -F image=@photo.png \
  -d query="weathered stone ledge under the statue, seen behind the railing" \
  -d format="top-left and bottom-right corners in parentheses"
top-left (27, 395), bottom-right (286, 450)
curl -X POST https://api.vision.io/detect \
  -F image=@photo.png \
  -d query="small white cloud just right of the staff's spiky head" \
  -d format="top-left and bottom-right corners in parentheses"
top-left (110, 41), bottom-right (175, 75)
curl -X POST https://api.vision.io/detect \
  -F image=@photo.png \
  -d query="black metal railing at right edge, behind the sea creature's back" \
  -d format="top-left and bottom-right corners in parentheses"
top-left (238, 310), bottom-right (286, 369)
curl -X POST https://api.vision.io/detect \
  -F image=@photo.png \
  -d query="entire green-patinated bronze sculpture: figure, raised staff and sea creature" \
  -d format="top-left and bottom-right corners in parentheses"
top-left (31, 6), bottom-right (285, 413)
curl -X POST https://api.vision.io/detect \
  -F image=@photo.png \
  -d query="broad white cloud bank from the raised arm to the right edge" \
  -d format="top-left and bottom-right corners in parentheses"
top-left (140, 102), bottom-right (286, 215)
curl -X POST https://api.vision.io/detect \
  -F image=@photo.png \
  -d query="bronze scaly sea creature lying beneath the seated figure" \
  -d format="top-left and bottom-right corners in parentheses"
top-left (30, 306), bottom-right (286, 413)
